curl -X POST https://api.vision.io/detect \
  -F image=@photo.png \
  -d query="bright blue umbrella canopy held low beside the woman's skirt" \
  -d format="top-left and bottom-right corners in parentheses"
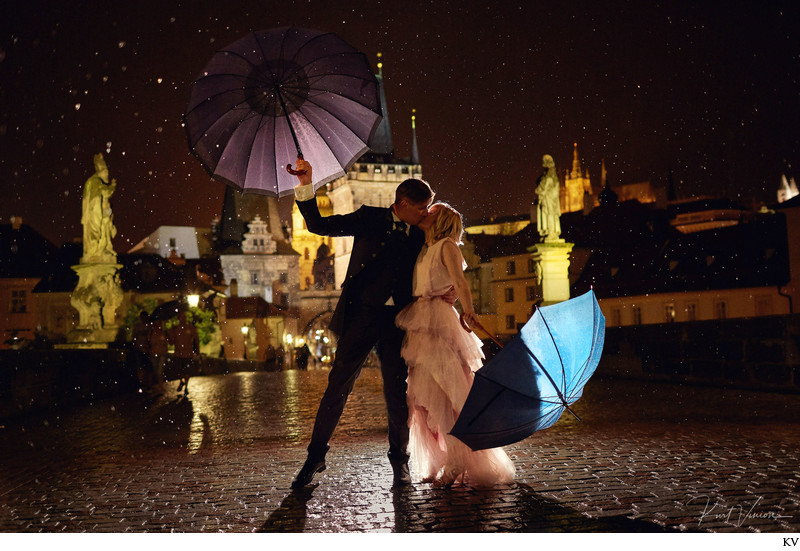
top-left (450, 291), bottom-right (605, 450)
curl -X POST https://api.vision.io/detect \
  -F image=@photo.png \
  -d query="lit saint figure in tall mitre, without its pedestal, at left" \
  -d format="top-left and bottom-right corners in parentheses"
top-left (81, 153), bottom-right (117, 261)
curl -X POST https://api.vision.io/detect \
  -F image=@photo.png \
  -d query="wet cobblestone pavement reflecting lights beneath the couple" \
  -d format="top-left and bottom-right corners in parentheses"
top-left (0, 369), bottom-right (800, 533)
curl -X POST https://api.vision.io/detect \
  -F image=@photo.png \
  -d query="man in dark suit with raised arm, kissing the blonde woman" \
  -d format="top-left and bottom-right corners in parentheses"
top-left (292, 159), bottom-right (434, 489)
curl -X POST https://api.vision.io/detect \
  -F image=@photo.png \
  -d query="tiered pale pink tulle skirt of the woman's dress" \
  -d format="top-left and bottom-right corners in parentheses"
top-left (396, 297), bottom-right (514, 486)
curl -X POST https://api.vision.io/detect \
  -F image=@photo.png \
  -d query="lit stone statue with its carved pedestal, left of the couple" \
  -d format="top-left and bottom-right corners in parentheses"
top-left (68, 153), bottom-right (123, 343)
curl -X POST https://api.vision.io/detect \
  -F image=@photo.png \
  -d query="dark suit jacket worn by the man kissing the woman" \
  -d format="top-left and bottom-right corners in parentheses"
top-left (297, 197), bottom-right (425, 336)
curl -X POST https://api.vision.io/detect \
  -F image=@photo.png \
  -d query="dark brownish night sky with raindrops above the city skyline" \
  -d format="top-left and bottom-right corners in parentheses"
top-left (0, 0), bottom-right (800, 248)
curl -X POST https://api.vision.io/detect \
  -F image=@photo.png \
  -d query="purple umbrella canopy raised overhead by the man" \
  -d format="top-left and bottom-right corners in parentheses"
top-left (184, 27), bottom-right (382, 197)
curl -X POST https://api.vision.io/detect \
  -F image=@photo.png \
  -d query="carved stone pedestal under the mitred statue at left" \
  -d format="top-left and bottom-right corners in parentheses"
top-left (67, 257), bottom-right (122, 343)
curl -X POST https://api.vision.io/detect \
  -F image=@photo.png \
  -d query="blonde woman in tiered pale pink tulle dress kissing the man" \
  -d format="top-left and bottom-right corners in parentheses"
top-left (396, 203), bottom-right (514, 486)
